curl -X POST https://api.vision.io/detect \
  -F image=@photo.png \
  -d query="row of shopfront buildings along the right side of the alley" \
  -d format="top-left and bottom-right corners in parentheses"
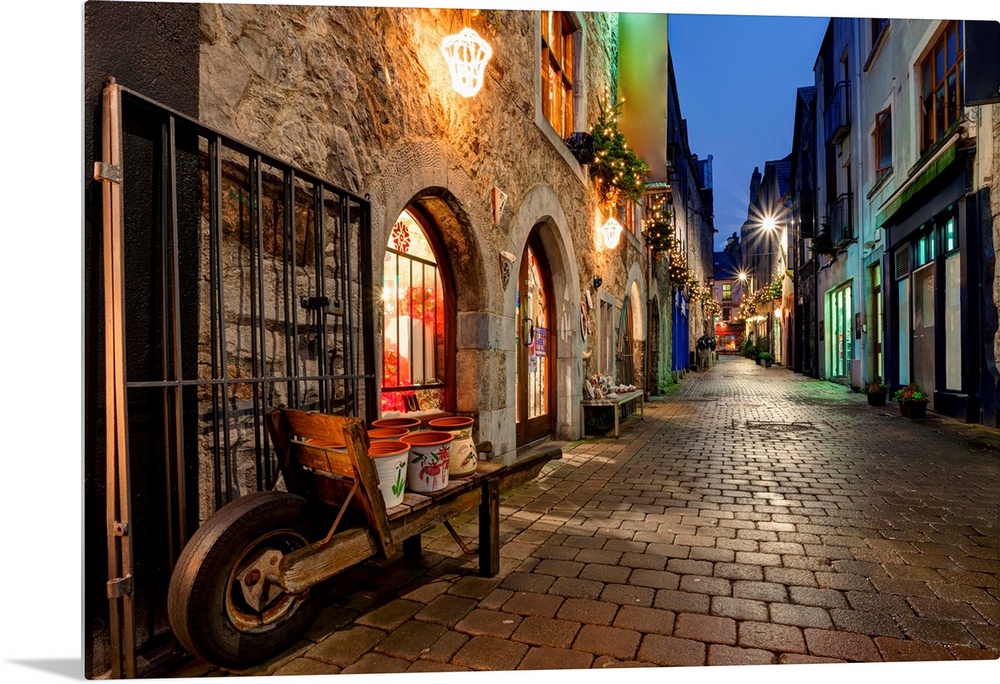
top-left (728, 18), bottom-right (1000, 426)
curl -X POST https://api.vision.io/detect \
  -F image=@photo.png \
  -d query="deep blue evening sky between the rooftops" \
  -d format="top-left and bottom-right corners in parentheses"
top-left (669, 14), bottom-right (830, 249)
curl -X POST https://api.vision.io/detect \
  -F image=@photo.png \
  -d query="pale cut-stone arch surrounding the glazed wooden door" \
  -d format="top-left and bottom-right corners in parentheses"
top-left (502, 185), bottom-right (583, 448)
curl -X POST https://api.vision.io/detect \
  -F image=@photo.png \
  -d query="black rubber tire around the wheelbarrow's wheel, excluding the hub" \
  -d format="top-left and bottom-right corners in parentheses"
top-left (167, 492), bottom-right (322, 668)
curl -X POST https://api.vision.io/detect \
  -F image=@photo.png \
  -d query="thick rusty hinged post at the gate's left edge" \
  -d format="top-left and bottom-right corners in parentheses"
top-left (101, 79), bottom-right (136, 679)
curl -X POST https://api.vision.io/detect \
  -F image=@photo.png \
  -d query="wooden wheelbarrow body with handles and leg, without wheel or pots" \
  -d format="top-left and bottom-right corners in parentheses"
top-left (267, 409), bottom-right (562, 593)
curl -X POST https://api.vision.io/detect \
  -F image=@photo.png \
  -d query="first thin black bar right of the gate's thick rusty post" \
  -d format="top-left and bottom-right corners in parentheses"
top-left (165, 116), bottom-right (188, 556)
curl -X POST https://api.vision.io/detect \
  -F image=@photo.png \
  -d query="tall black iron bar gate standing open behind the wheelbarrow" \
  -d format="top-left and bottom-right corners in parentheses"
top-left (94, 79), bottom-right (377, 678)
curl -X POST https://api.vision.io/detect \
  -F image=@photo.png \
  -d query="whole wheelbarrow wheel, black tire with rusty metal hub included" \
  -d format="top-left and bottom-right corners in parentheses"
top-left (167, 492), bottom-right (321, 668)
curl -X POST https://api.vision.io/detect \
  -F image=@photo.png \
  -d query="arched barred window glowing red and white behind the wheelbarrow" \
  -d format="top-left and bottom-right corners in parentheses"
top-left (382, 211), bottom-right (454, 413)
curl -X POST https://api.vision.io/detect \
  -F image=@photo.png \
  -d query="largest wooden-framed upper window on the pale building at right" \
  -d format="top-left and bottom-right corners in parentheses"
top-left (919, 21), bottom-right (965, 153)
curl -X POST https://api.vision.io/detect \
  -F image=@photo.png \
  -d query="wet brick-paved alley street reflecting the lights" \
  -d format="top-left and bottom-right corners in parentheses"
top-left (171, 357), bottom-right (1000, 676)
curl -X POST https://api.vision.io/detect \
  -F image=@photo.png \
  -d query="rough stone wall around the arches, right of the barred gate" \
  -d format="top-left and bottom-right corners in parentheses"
top-left (199, 4), bottom-right (642, 456)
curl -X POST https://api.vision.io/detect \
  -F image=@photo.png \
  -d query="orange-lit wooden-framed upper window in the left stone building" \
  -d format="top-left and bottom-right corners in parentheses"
top-left (541, 12), bottom-right (574, 139)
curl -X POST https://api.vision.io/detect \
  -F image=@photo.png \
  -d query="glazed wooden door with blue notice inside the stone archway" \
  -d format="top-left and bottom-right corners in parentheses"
top-left (515, 231), bottom-right (557, 446)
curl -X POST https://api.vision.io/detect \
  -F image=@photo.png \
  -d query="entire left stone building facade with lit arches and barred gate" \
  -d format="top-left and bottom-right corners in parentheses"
top-left (84, 3), bottom-right (676, 675)
